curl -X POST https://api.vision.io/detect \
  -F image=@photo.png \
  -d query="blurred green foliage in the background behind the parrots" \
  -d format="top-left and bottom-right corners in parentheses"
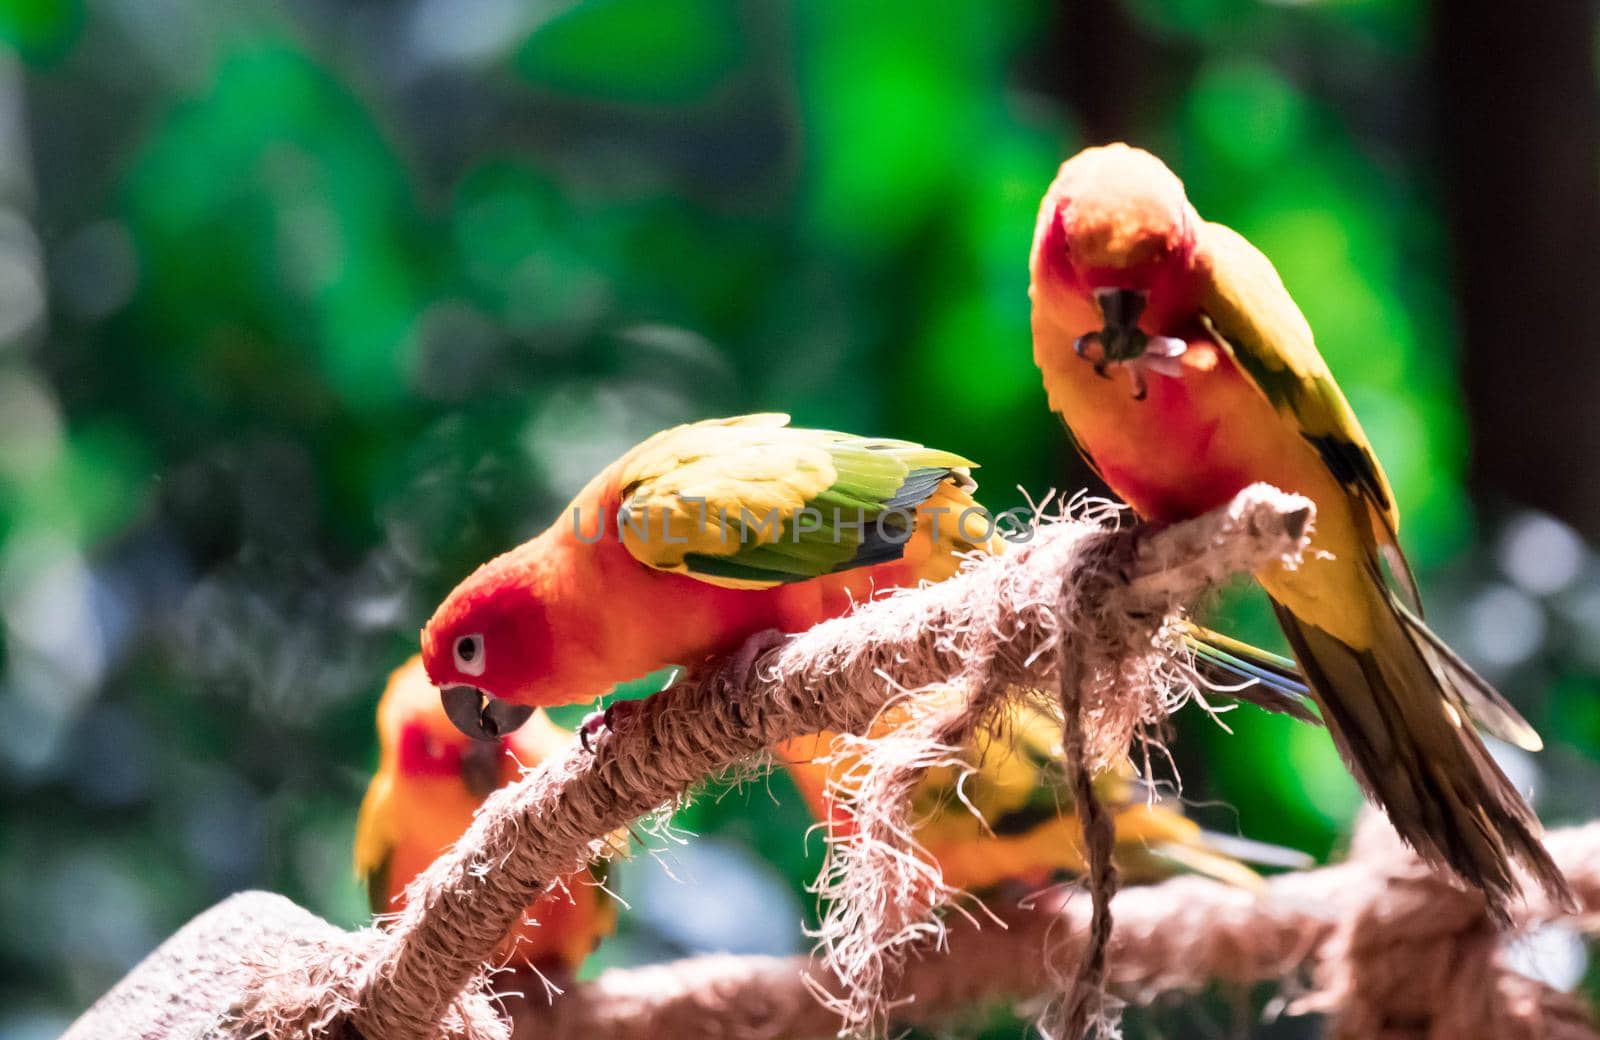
top-left (0, 0), bottom-right (1600, 1037)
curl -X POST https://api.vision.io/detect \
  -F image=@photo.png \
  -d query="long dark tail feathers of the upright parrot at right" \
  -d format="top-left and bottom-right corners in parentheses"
top-left (1274, 592), bottom-right (1574, 920)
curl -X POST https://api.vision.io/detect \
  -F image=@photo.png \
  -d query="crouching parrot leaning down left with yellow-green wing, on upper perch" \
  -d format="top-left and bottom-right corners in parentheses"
top-left (422, 414), bottom-right (994, 736)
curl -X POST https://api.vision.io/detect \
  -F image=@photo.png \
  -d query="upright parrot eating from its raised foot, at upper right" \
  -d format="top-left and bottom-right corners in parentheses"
top-left (1030, 144), bottom-right (1570, 910)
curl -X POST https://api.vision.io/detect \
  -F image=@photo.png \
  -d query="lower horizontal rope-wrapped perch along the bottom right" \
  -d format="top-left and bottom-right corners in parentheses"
top-left (517, 819), bottom-right (1600, 1040)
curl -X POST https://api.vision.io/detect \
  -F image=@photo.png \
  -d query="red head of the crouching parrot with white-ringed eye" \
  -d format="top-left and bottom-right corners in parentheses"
top-left (422, 555), bottom-right (565, 739)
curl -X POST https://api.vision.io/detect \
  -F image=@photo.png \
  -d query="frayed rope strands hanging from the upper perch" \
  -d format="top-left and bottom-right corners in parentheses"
top-left (813, 499), bottom-right (1267, 1037)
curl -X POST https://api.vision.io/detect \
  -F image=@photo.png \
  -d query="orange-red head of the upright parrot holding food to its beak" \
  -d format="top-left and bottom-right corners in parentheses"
top-left (1032, 144), bottom-right (1200, 362)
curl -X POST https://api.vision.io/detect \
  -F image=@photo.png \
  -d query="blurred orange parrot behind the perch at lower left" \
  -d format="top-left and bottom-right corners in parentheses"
top-left (355, 656), bottom-right (616, 974)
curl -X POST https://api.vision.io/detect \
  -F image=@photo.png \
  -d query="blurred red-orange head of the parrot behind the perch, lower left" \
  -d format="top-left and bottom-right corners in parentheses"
top-left (378, 658), bottom-right (517, 798)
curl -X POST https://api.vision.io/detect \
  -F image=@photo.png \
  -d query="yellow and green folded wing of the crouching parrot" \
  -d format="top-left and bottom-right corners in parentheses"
top-left (616, 414), bottom-right (982, 589)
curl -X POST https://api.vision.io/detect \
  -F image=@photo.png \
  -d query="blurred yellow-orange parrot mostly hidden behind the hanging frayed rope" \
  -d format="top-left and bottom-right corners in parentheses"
top-left (774, 693), bottom-right (1312, 894)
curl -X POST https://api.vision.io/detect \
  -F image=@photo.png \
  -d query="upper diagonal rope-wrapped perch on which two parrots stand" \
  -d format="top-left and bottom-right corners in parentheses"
top-left (240, 485), bottom-right (1312, 1040)
